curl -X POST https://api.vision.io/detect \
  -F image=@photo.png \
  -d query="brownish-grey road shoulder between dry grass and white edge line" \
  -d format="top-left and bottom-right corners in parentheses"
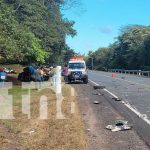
top-left (72, 83), bottom-right (150, 150)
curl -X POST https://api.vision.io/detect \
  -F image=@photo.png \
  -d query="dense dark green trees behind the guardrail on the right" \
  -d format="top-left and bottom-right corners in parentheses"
top-left (87, 25), bottom-right (150, 70)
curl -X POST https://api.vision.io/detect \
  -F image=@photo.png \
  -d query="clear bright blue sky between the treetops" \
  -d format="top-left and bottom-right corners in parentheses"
top-left (63, 0), bottom-right (150, 54)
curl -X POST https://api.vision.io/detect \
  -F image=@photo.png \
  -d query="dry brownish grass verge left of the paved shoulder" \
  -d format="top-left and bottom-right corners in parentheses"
top-left (0, 66), bottom-right (88, 150)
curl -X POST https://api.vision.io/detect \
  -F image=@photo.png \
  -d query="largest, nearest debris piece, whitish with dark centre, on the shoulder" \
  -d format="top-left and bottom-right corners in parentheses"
top-left (106, 120), bottom-right (132, 132)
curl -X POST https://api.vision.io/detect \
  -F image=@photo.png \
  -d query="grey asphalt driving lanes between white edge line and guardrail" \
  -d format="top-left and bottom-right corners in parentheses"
top-left (88, 71), bottom-right (150, 120)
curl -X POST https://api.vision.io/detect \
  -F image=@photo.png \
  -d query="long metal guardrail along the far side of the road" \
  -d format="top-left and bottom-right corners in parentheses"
top-left (108, 69), bottom-right (150, 77)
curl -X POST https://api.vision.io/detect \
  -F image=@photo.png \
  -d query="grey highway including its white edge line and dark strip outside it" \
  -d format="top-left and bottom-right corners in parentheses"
top-left (88, 71), bottom-right (150, 146)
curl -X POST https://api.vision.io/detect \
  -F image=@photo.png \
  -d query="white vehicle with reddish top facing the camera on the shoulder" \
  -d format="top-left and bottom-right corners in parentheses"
top-left (67, 57), bottom-right (88, 84)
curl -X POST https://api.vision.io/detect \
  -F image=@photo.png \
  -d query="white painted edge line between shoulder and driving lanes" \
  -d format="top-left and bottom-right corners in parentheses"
top-left (89, 79), bottom-right (150, 125)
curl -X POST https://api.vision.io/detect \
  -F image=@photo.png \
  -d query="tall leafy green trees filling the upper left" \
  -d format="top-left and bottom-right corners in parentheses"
top-left (0, 0), bottom-right (76, 64)
